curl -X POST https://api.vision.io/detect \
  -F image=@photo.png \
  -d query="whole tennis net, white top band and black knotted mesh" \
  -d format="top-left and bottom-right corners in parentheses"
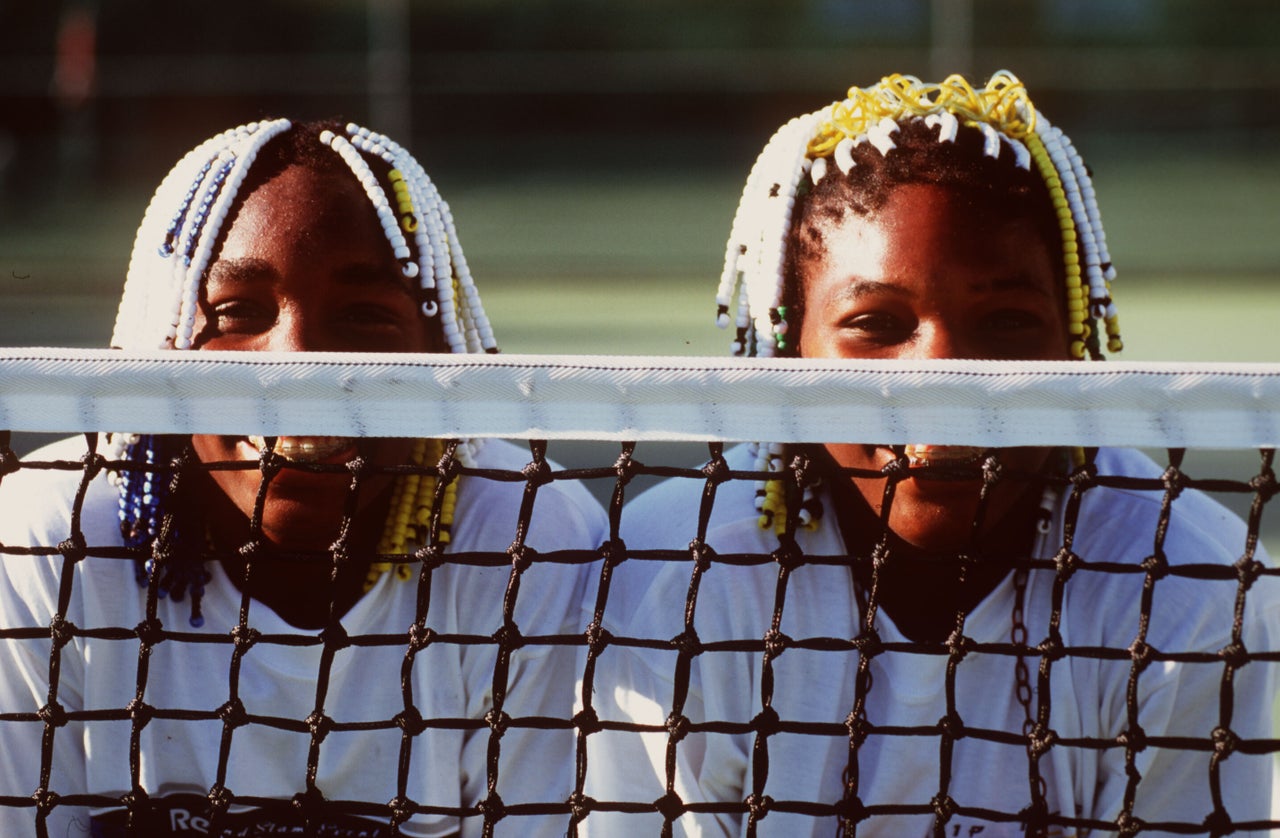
top-left (0, 349), bottom-right (1280, 835)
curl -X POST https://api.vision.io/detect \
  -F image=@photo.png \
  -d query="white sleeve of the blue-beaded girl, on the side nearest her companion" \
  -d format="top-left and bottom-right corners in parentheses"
top-left (456, 443), bottom-right (608, 838)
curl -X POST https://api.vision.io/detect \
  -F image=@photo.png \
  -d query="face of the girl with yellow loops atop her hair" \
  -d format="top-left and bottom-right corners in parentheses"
top-left (797, 184), bottom-right (1069, 551)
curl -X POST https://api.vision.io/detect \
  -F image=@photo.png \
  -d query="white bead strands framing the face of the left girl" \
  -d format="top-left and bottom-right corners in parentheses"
top-left (108, 119), bottom-right (497, 464)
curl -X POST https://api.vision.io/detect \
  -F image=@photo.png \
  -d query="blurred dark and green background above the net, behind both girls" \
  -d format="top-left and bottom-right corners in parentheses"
top-left (0, 0), bottom-right (1280, 546)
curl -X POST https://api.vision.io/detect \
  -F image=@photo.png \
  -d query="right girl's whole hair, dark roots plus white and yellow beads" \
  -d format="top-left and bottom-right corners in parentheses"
top-left (717, 72), bottom-right (1123, 531)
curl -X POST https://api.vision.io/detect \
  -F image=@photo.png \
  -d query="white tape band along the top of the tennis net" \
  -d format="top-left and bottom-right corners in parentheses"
top-left (0, 348), bottom-right (1280, 448)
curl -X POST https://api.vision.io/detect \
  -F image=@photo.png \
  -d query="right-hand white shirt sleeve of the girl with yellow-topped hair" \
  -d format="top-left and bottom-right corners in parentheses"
top-left (1080, 458), bottom-right (1280, 835)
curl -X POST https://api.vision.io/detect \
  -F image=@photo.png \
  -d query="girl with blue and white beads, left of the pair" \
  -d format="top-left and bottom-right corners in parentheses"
top-left (0, 119), bottom-right (604, 838)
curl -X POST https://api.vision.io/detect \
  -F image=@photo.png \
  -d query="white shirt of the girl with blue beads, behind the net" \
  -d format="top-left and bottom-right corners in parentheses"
top-left (0, 440), bottom-right (605, 838)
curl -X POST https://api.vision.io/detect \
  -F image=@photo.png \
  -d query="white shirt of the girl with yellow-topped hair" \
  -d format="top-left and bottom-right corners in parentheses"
top-left (585, 450), bottom-right (1280, 838)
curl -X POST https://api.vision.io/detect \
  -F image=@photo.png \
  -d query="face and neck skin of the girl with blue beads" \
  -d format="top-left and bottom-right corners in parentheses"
top-left (192, 165), bottom-right (440, 624)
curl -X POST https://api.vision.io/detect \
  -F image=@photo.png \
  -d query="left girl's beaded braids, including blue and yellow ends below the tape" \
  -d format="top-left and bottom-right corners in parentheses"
top-left (108, 119), bottom-right (497, 626)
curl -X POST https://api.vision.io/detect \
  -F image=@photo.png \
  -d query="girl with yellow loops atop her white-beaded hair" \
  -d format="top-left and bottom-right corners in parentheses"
top-left (586, 73), bottom-right (1280, 838)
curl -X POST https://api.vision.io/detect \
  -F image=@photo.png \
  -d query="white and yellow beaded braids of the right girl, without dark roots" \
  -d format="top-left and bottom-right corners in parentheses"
top-left (716, 70), bottom-right (1124, 532)
